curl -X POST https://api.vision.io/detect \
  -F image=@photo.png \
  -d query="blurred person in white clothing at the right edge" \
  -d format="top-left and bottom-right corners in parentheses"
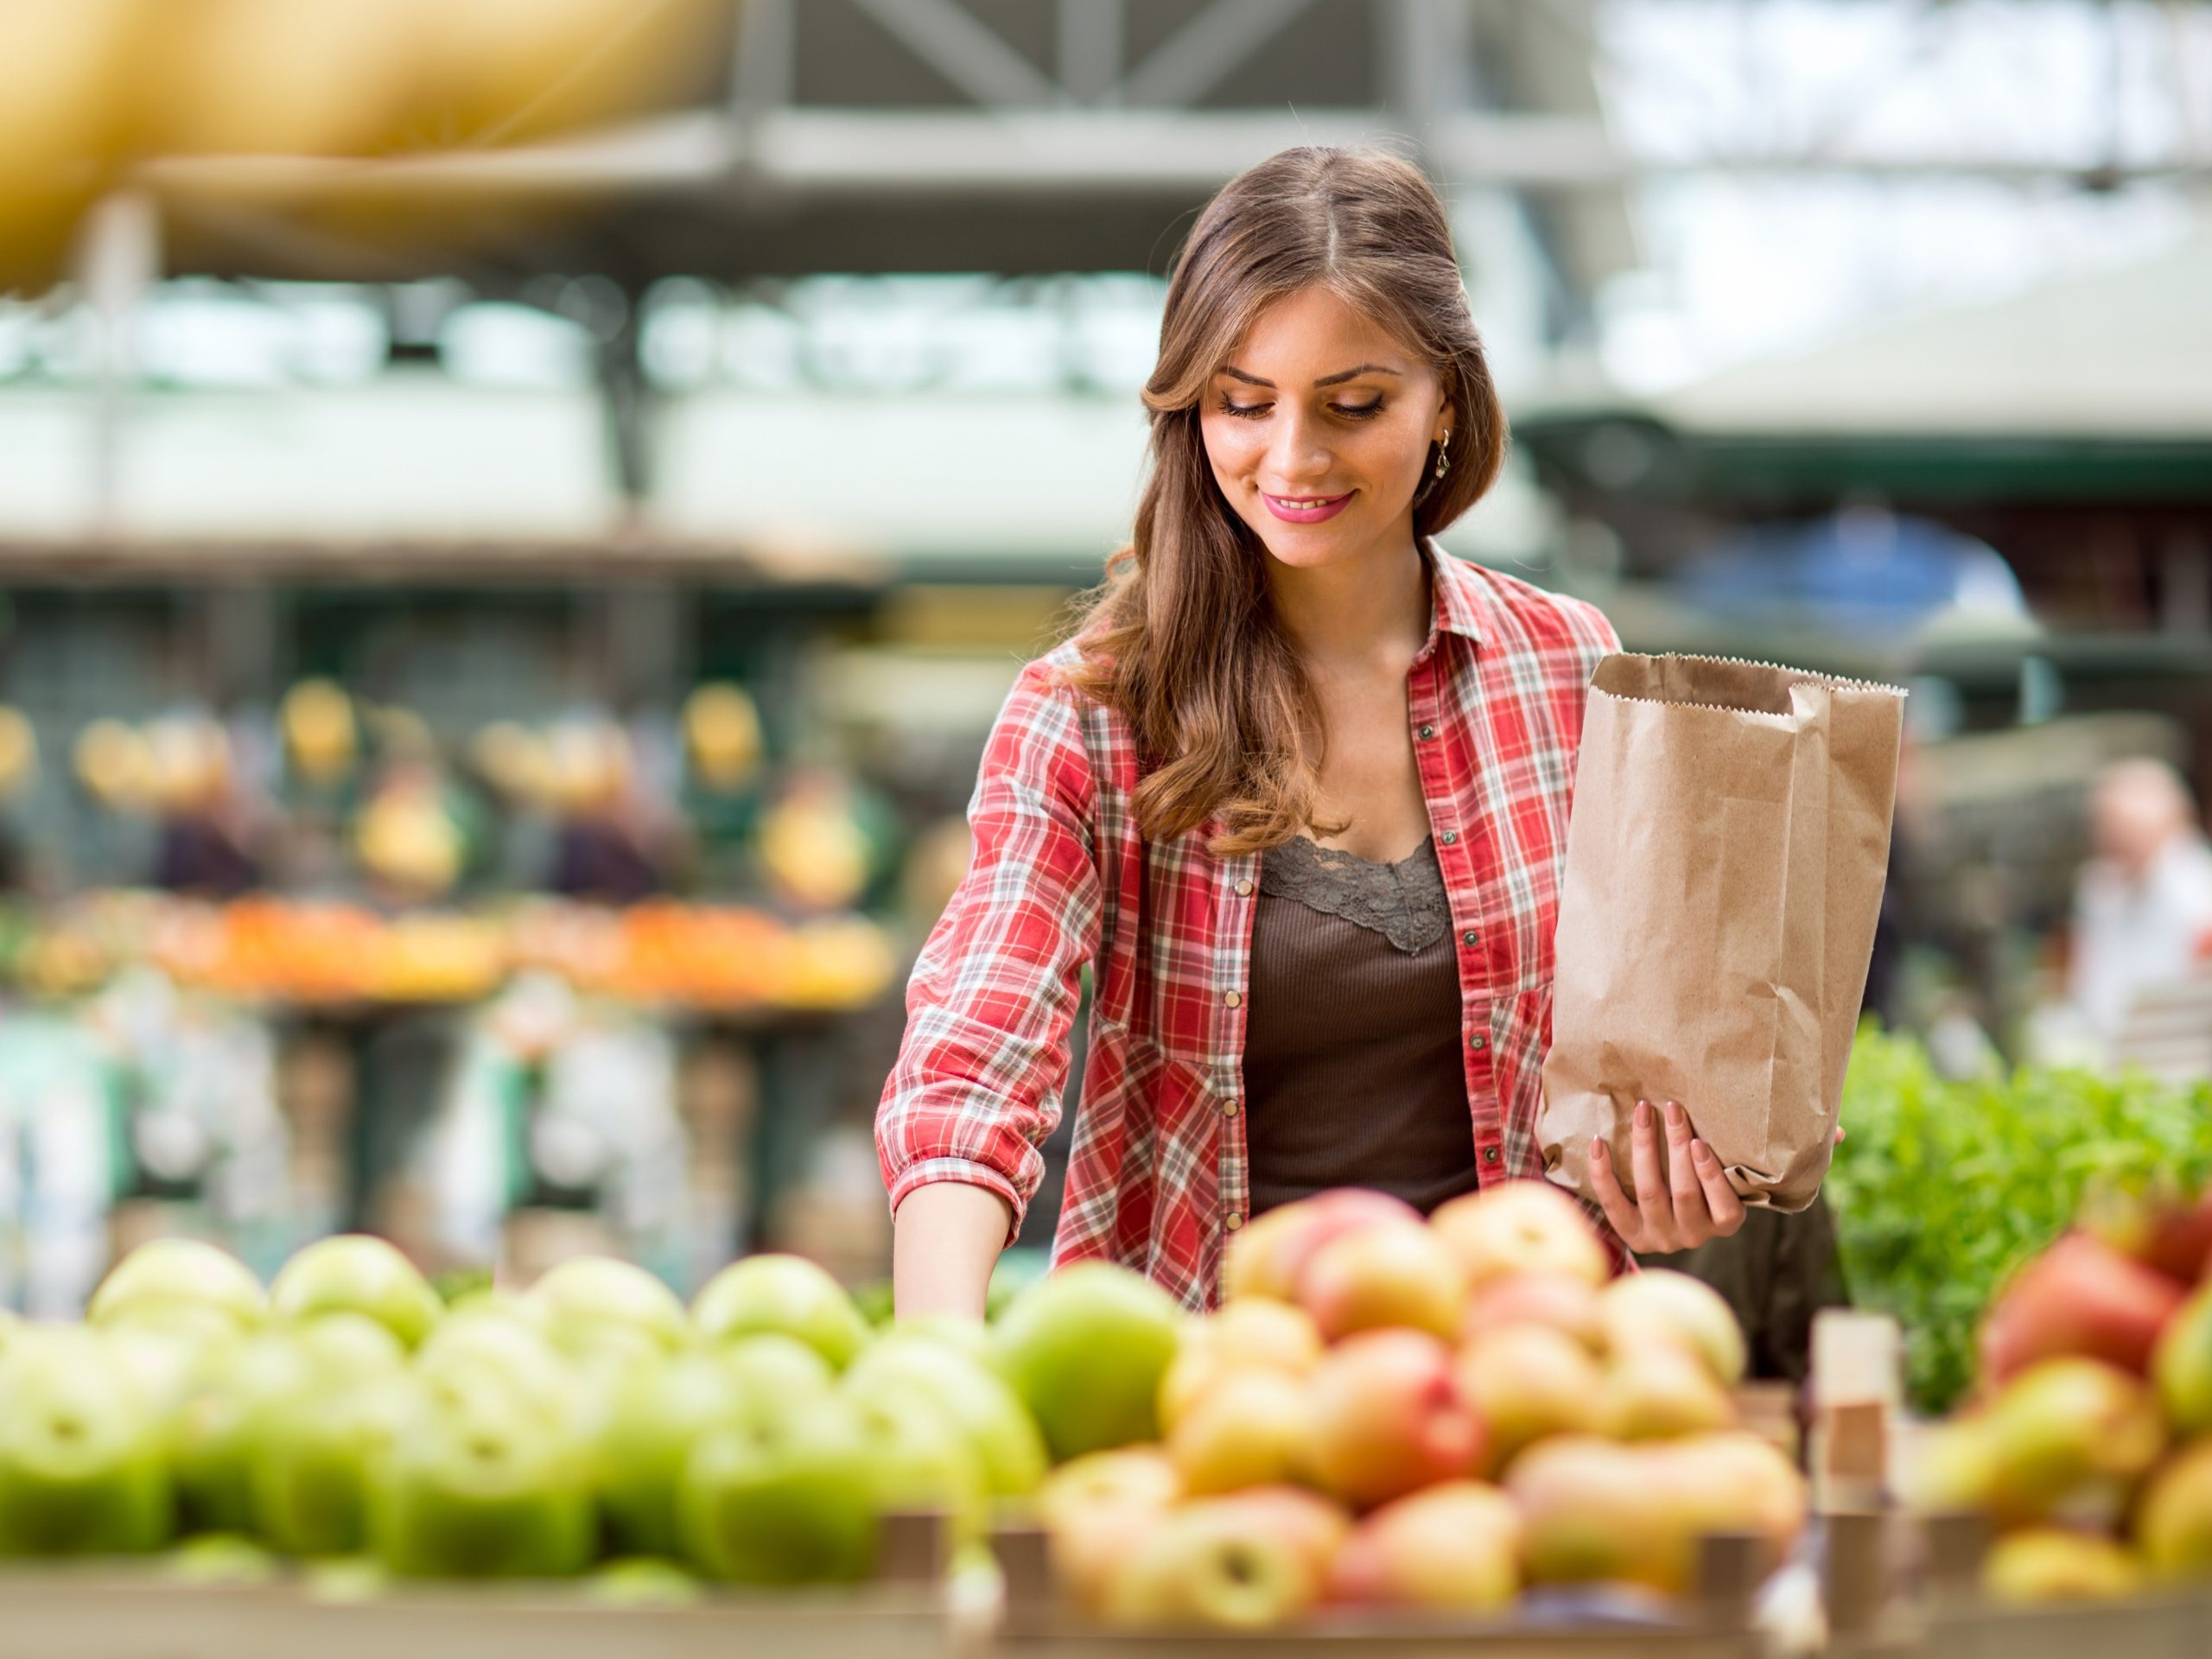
top-left (2069, 759), bottom-right (2212, 1046)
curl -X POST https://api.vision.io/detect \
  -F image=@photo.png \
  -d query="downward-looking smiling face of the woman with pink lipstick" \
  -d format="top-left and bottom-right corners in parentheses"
top-left (1199, 288), bottom-right (1451, 566)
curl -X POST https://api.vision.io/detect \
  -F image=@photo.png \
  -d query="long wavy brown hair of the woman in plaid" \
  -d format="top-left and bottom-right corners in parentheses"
top-left (1064, 143), bottom-right (1506, 854)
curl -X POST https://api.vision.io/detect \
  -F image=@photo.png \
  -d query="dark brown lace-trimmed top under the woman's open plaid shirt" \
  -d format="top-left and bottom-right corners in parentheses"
top-left (1243, 836), bottom-right (1478, 1214)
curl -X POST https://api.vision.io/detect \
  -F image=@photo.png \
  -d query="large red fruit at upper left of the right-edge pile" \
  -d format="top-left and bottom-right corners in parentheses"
top-left (1982, 1232), bottom-right (2188, 1382)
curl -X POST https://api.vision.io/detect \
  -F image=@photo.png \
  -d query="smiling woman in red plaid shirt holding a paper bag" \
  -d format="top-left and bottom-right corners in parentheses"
top-left (876, 146), bottom-right (1743, 1316)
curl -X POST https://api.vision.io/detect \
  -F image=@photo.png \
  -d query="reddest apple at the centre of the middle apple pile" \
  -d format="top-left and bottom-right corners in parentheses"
top-left (1312, 1330), bottom-right (1484, 1509)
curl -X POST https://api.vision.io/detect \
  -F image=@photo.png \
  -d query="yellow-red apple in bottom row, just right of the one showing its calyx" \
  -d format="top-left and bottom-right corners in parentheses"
top-left (1330, 1480), bottom-right (1522, 1612)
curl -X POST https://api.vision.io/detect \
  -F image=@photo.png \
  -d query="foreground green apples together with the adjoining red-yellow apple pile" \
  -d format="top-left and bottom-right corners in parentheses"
top-left (0, 1184), bottom-right (1805, 1630)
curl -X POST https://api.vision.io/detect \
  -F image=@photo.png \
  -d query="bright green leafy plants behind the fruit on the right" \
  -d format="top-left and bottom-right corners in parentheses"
top-left (1827, 1024), bottom-right (2212, 1411)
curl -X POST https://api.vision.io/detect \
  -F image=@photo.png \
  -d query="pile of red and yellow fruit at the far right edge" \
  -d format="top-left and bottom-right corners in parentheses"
top-left (1900, 1197), bottom-right (2212, 1604)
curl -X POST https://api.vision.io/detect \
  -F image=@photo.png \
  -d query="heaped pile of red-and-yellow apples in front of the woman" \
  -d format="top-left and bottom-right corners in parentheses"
top-left (1026, 1181), bottom-right (1805, 1628)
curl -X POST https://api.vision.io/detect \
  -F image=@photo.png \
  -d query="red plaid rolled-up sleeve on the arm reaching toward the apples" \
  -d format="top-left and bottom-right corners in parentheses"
top-left (876, 664), bottom-right (1102, 1243)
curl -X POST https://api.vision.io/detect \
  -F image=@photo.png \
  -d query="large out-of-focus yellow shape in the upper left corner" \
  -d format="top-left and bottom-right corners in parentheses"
top-left (0, 0), bottom-right (730, 285)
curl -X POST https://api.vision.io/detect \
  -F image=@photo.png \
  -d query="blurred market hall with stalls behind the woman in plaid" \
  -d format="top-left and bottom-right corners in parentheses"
top-left (0, 0), bottom-right (2212, 1314)
